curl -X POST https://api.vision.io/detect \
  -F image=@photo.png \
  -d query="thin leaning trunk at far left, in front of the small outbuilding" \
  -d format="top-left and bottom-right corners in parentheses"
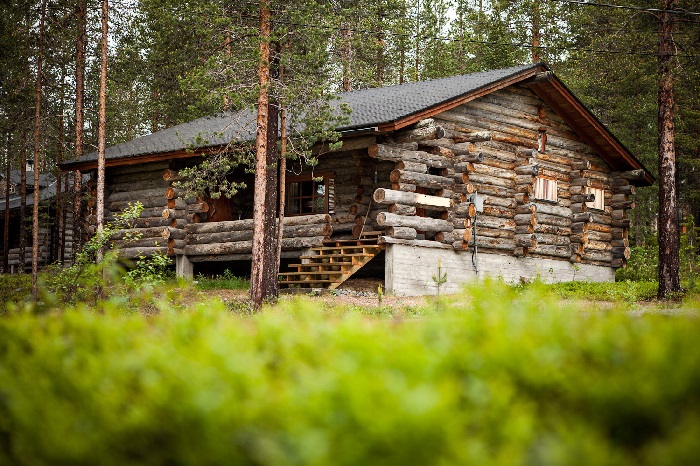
top-left (32, 0), bottom-right (46, 300)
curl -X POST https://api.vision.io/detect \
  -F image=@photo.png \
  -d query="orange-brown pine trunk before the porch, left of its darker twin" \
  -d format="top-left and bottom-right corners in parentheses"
top-left (250, 0), bottom-right (270, 309)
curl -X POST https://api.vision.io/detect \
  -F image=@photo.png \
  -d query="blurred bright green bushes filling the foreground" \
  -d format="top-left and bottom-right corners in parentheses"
top-left (0, 284), bottom-right (700, 465)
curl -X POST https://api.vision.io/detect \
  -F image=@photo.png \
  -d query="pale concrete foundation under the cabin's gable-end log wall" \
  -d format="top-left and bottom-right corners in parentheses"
top-left (384, 244), bottom-right (615, 296)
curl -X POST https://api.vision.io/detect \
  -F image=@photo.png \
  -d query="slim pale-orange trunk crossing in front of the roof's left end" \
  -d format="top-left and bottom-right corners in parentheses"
top-left (96, 0), bottom-right (109, 251)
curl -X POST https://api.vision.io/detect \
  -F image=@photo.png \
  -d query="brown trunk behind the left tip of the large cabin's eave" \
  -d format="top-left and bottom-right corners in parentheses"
top-left (71, 0), bottom-right (87, 261)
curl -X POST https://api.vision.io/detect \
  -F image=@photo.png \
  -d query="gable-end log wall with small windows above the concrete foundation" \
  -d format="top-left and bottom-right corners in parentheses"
top-left (368, 85), bottom-right (637, 267)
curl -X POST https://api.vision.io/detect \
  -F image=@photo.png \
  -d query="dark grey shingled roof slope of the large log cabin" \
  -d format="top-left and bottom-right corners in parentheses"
top-left (65, 63), bottom-right (542, 165)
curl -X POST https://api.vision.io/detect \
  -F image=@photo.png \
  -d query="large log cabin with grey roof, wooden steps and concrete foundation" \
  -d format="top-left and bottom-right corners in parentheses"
top-left (61, 63), bottom-right (654, 295)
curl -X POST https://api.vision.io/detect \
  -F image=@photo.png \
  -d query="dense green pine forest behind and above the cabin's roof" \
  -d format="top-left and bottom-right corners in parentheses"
top-left (0, 0), bottom-right (700, 245)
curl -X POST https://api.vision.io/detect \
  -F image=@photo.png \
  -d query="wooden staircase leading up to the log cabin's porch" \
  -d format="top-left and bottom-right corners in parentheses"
top-left (279, 232), bottom-right (384, 290)
